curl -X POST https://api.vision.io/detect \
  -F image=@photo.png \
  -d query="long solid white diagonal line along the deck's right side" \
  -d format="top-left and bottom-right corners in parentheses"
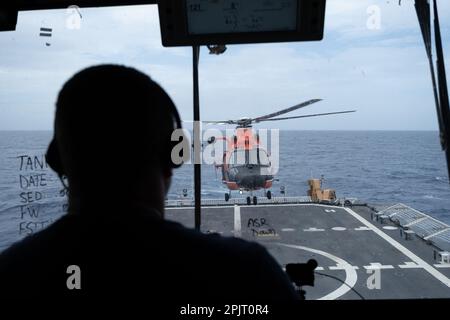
top-left (344, 208), bottom-right (450, 287)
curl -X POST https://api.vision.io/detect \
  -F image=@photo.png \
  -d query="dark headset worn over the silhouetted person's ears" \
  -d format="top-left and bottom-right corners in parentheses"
top-left (45, 81), bottom-right (190, 178)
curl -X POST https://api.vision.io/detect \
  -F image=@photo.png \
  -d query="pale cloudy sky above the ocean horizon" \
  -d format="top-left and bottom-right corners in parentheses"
top-left (0, 0), bottom-right (450, 130)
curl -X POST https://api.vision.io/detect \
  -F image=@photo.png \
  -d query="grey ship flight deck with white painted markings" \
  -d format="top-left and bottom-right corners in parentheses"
top-left (166, 197), bottom-right (450, 300)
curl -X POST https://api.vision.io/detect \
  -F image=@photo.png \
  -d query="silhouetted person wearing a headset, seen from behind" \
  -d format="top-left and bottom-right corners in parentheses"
top-left (0, 65), bottom-right (296, 302)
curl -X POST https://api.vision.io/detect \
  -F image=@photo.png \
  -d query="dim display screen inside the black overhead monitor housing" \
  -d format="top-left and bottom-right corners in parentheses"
top-left (186, 0), bottom-right (300, 35)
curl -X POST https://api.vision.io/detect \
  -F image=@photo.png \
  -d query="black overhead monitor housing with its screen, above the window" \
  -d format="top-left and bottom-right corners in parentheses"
top-left (158, 0), bottom-right (326, 47)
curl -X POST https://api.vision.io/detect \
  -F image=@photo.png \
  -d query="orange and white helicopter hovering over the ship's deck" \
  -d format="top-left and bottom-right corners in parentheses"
top-left (203, 99), bottom-right (356, 205)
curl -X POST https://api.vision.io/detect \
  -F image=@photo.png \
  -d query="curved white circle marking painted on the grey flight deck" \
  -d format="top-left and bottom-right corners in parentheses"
top-left (278, 243), bottom-right (358, 300)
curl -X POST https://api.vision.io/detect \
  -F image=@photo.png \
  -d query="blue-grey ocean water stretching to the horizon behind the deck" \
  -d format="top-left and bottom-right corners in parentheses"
top-left (0, 131), bottom-right (450, 251)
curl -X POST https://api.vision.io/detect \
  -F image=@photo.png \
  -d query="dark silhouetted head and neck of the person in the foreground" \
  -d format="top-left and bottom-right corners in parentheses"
top-left (47, 65), bottom-right (186, 213)
